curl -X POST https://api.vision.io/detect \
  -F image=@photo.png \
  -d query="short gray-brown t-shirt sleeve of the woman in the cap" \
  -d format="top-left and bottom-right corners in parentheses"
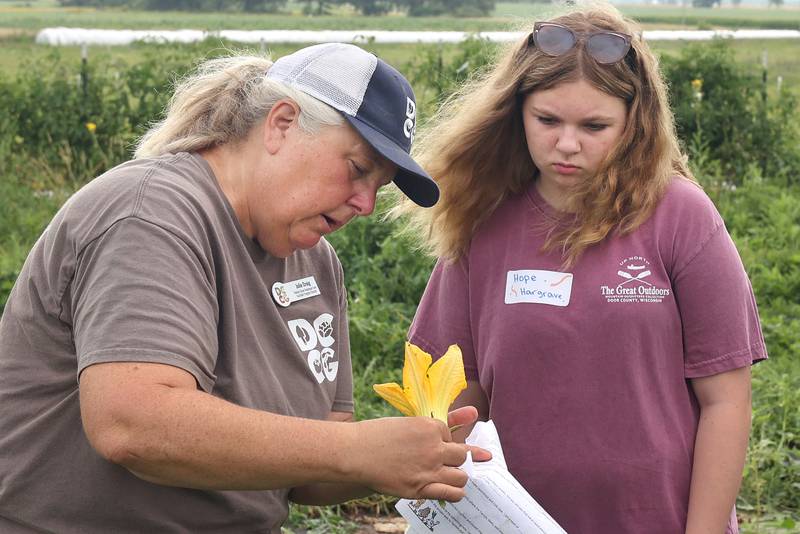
top-left (71, 217), bottom-right (218, 392)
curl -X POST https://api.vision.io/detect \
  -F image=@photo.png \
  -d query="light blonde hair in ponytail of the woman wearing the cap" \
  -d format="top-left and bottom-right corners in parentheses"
top-left (134, 56), bottom-right (344, 158)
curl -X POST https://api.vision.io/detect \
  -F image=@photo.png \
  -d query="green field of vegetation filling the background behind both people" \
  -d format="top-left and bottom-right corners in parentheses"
top-left (0, 2), bottom-right (800, 534)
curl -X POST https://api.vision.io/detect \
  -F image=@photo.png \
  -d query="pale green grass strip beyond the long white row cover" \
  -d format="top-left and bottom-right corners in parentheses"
top-left (0, 1), bottom-right (800, 32)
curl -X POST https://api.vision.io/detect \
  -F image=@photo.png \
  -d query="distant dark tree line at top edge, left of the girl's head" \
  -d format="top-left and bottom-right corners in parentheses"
top-left (59, 0), bottom-right (495, 17)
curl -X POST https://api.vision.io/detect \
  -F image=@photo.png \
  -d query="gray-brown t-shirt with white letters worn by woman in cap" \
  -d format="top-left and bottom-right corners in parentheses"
top-left (0, 153), bottom-right (353, 533)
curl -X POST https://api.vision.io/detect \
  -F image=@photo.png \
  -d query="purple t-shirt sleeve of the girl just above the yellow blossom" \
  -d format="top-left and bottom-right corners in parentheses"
top-left (408, 259), bottom-right (478, 380)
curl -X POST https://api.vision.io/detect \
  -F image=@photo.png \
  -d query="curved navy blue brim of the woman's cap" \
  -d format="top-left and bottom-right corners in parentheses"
top-left (342, 113), bottom-right (439, 208)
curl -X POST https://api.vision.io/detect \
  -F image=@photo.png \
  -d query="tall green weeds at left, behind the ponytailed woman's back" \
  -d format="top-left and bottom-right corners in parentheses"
top-left (0, 40), bottom-right (244, 187)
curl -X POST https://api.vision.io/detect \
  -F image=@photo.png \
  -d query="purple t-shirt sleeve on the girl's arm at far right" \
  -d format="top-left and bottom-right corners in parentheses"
top-left (673, 219), bottom-right (767, 378)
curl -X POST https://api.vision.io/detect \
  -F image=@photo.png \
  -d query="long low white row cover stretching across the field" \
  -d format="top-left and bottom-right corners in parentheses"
top-left (36, 28), bottom-right (800, 46)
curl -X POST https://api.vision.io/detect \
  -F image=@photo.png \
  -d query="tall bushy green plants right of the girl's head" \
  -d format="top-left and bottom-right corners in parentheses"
top-left (662, 39), bottom-right (800, 184)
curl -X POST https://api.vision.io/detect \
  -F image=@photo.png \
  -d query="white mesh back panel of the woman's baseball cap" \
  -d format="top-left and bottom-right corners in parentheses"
top-left (267, 43), bottom-right (378, 116)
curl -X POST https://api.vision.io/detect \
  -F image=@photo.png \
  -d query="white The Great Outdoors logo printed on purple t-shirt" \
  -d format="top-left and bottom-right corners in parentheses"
top-left (600, 256), bottom-right (672, 303)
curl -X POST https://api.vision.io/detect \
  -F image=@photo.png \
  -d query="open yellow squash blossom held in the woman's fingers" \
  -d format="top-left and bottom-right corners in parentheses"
top-left (372, 342), bottom-right (467, 424)
